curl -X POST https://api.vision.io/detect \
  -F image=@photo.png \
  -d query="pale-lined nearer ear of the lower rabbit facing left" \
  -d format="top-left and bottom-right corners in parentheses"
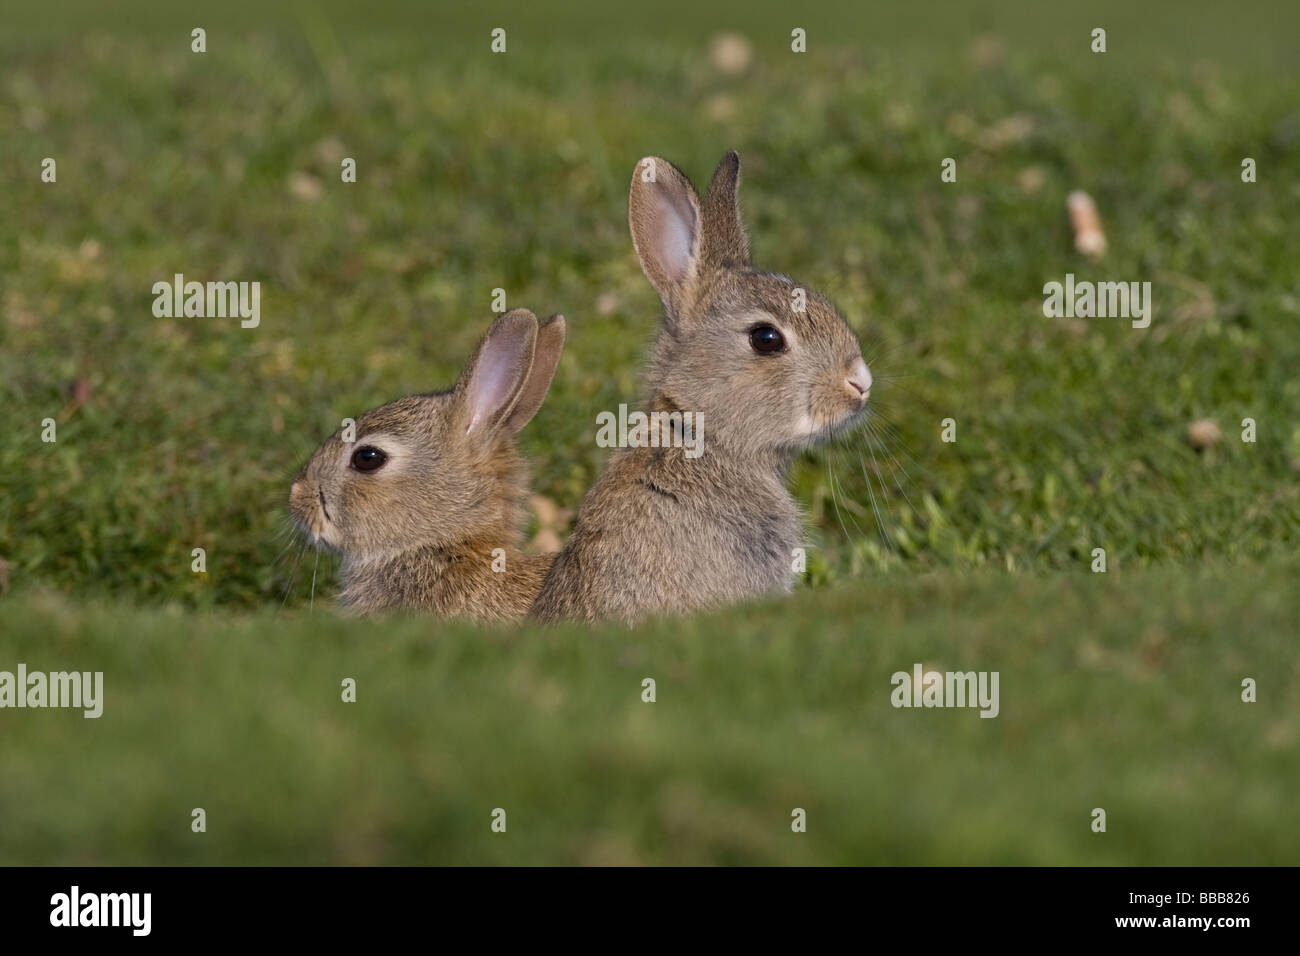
top-left (456, 308), bottom-right (537, 434)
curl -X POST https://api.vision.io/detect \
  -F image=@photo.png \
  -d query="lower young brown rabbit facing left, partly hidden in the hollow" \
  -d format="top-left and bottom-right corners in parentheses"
top-left (289, 308), bottom-right (564, 620)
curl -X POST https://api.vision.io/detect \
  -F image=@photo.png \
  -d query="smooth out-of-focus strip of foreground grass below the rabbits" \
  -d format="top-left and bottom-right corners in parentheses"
top-left (0, 561), bottom-right (1300, 865)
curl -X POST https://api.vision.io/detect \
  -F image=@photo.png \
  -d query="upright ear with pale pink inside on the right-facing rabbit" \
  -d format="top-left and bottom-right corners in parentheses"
top-left (628, 156), bottom-right (701, 316)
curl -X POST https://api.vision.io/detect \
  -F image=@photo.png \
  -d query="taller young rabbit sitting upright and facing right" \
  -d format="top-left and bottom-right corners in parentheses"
top-left (532, 152), bottom-right (871, 623)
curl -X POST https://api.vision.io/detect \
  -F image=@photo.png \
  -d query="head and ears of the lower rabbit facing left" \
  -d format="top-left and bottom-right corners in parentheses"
top-left (290, 308), bottom-right (564, 563)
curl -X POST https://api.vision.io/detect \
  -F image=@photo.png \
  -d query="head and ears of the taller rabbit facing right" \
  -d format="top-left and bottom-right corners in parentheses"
top-left (628, 152), bottom-right (871, 455)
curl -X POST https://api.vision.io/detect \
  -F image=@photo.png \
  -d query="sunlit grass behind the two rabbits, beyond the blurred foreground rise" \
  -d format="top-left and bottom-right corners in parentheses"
top-left (0, 5), bottom-right (1300, 607)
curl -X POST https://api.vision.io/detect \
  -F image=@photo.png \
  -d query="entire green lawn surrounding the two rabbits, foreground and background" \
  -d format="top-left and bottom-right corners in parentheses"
top-left (0, 1), bottom-right (1300, 862)
